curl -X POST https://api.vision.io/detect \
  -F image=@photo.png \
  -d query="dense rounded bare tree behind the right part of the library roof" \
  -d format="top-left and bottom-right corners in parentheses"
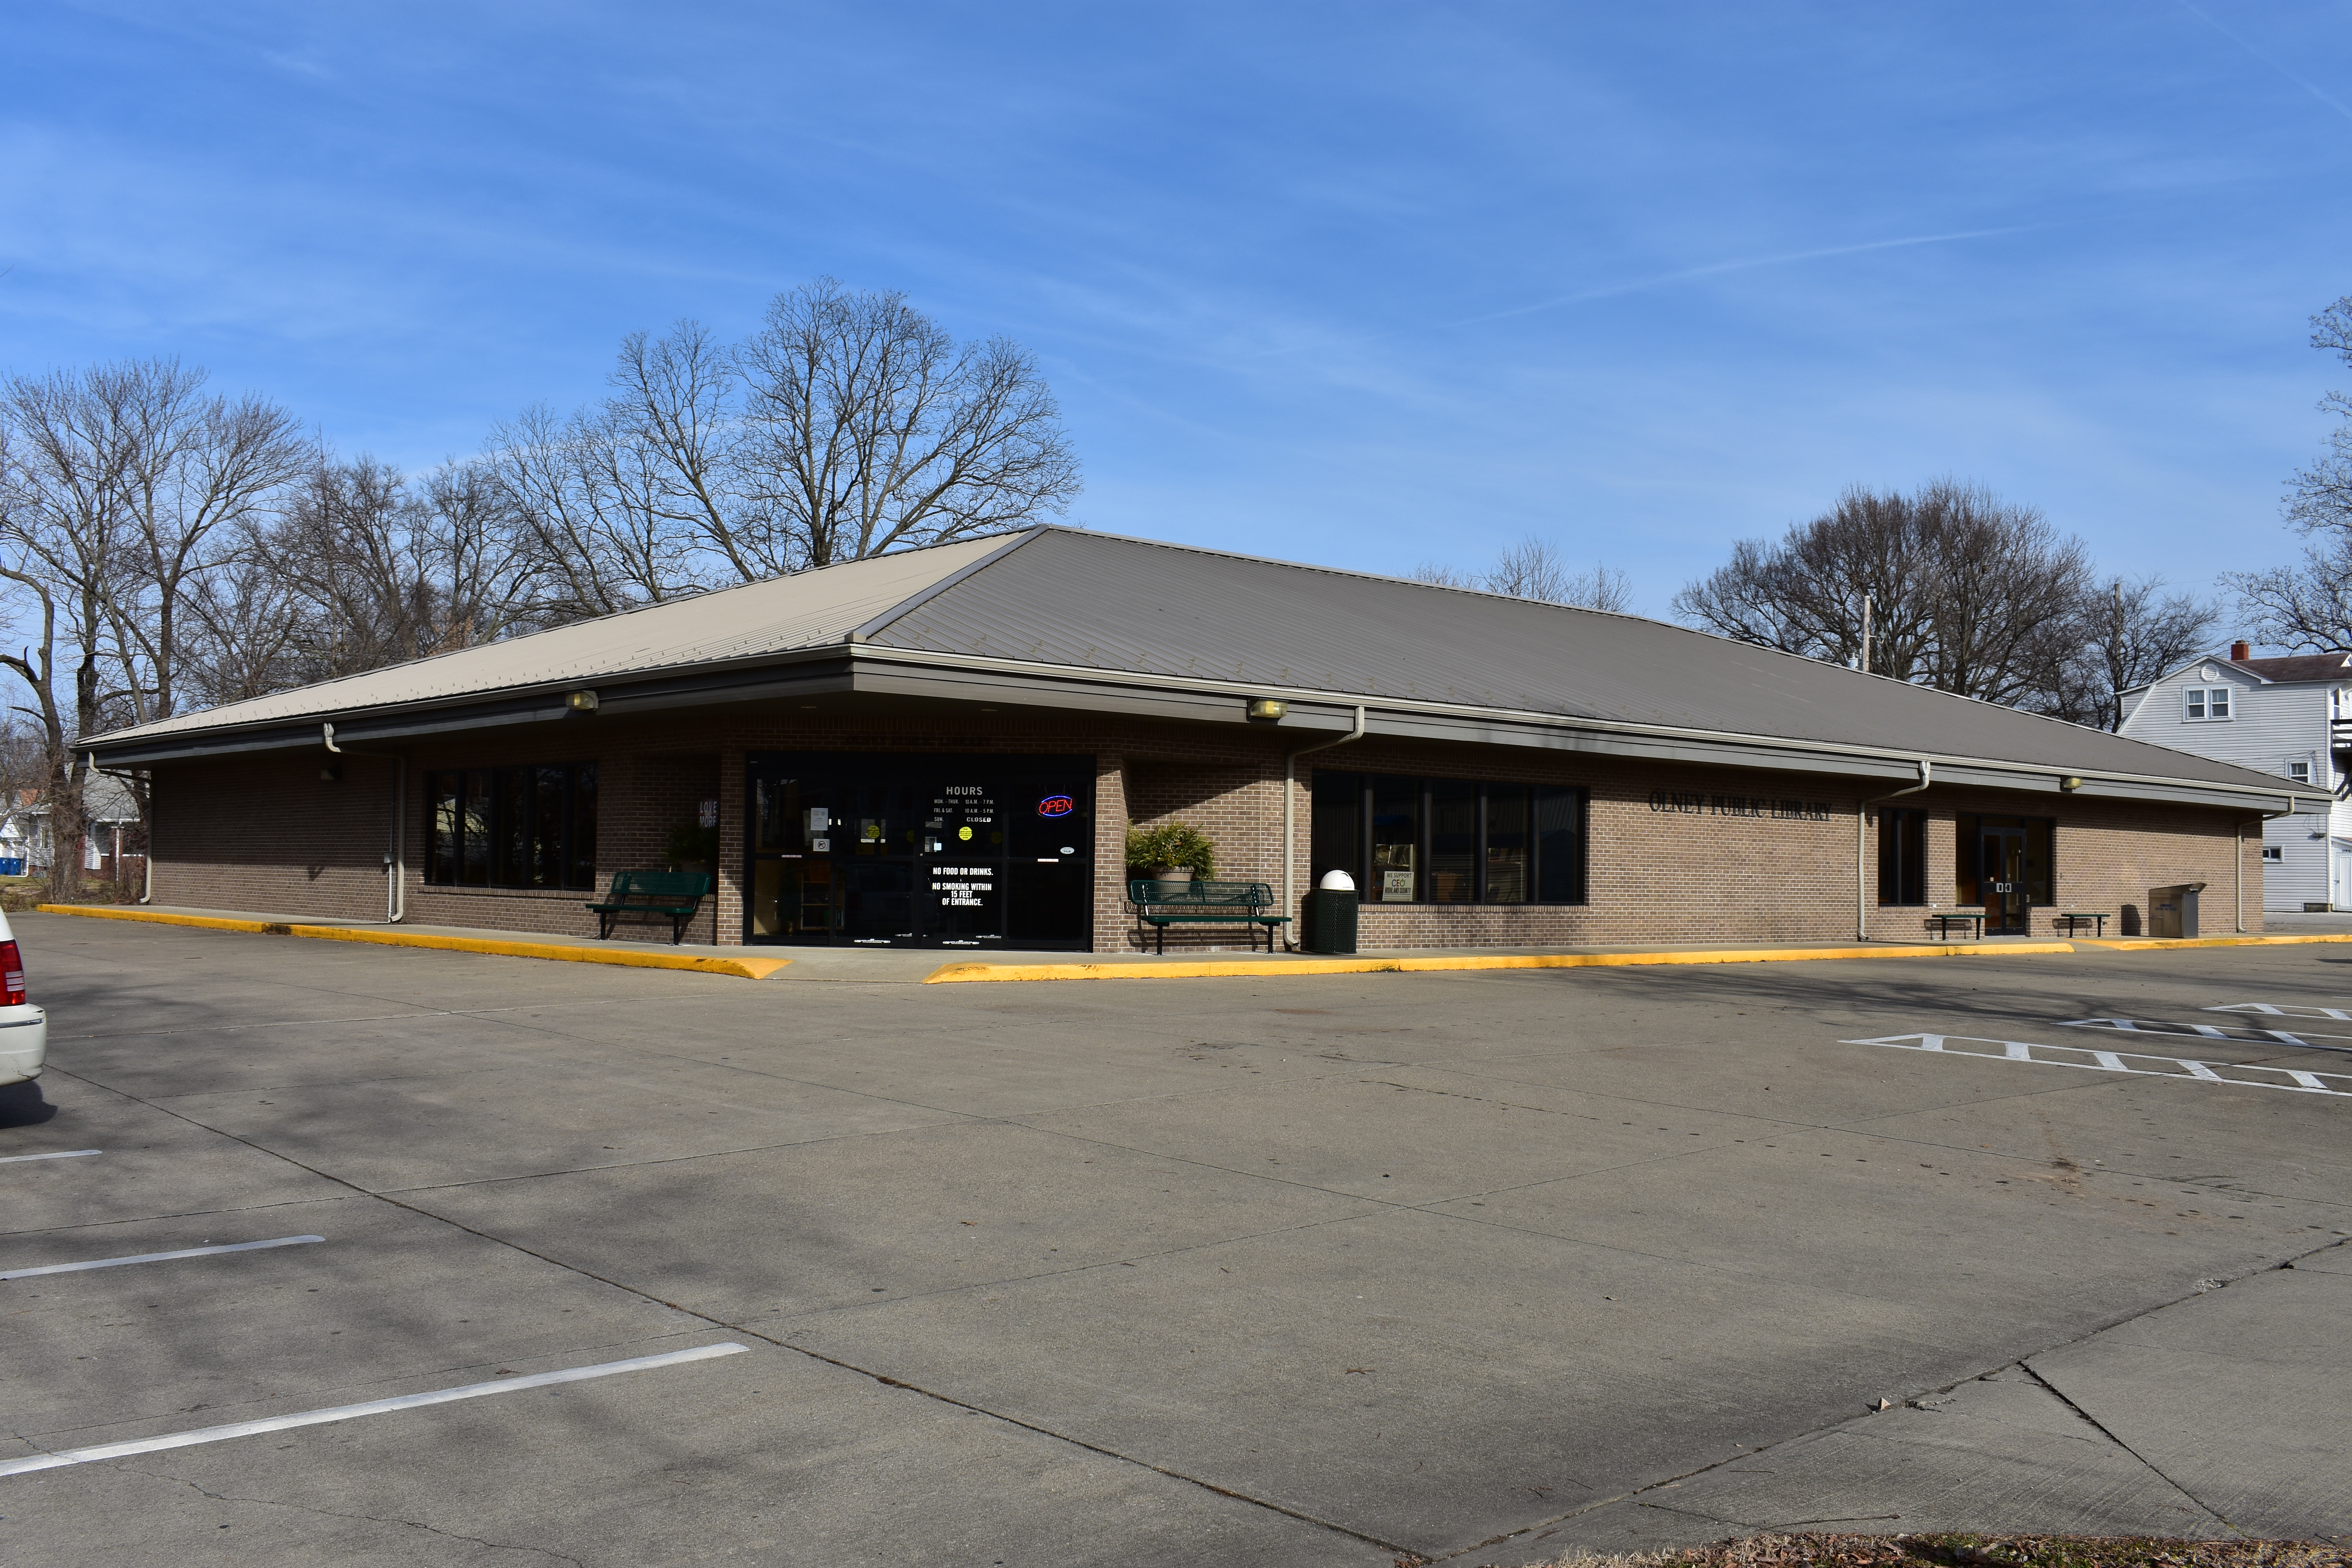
top-left (1675, 479), bottom-right (2091, 710)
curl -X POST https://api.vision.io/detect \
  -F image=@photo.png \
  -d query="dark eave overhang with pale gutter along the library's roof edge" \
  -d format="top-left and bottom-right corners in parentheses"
top-left (87, 644), bottom-right (2288, 813)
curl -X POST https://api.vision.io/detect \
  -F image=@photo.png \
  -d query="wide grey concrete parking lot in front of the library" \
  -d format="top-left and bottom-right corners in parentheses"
top-left (0, 915), bottom-right (2352, 1568)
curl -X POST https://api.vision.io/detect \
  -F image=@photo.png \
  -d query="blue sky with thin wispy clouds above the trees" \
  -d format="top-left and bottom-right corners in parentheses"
top-left (0, 0), bottom-right (2352, 613)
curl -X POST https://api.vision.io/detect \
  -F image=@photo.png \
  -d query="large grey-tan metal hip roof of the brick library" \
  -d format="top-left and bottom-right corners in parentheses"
top-left (87, 526), bottom-right (2279, 804)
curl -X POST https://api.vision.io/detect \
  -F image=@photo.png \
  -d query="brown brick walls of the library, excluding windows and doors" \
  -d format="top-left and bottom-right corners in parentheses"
top-left (142, 710), bottom-right (2263, 952)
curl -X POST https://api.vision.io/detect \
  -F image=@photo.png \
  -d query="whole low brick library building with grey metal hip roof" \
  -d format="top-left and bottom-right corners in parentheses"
top-left (87, 526), bottom-right (2296, 952)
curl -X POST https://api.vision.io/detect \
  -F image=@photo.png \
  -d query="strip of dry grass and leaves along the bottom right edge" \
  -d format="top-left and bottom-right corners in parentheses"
top-left (1526, 1535), bottom-right (2352, 1568)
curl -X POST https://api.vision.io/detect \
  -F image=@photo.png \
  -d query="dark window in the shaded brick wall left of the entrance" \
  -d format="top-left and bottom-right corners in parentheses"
top-left (426, 762), bottom-right (595, 889)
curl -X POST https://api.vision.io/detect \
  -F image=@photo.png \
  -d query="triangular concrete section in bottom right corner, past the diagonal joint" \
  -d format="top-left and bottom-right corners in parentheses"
top-left (1449, 1243), bottom-right (2352, 1568)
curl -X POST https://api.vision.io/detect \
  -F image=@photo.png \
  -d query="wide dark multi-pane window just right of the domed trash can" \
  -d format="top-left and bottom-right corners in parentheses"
top-left (1310, 771), bottom-right (1585, 905)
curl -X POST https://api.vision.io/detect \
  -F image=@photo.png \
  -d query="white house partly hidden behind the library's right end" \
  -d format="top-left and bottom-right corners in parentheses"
top-left (2119, 642), bottom-right (2352, 910)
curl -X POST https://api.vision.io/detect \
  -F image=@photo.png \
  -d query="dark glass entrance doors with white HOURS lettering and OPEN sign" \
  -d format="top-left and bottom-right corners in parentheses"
top-left (743, 752), bottom-right (1094, 947)
